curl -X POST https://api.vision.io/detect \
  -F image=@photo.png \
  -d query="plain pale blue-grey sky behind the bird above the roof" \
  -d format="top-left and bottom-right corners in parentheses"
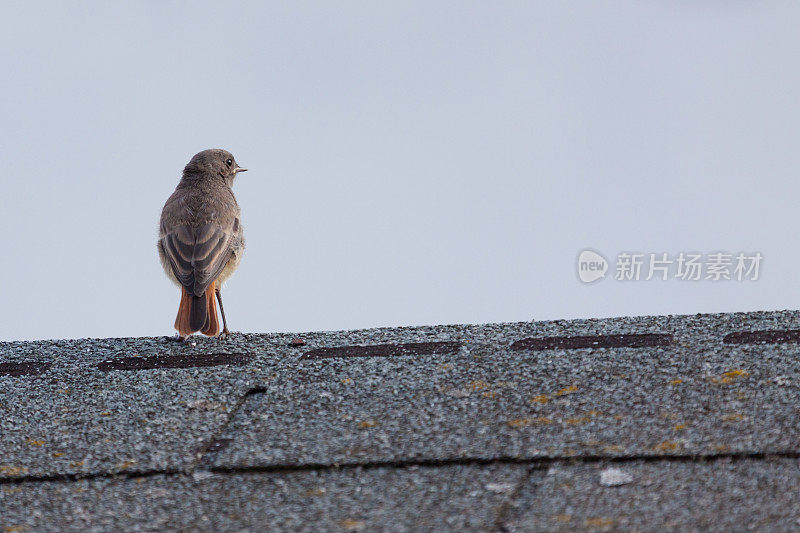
top-left (0, 0), bottom-right (800, 340)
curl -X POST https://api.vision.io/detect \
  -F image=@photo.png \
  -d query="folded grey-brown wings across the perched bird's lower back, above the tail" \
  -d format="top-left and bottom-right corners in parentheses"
top-left (161, 221), bottom-right (235, 296)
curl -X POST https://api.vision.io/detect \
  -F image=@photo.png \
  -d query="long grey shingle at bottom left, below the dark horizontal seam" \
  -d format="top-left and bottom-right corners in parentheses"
top-left (0, 465), bottom-right (527, 531)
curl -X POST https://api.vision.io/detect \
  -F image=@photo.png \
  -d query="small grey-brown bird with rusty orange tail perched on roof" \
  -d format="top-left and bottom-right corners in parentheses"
top-left (158, 149), bottom-right (247, 340)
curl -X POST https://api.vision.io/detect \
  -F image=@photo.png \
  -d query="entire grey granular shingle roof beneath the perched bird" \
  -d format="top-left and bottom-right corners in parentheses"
top-left (0, 311), bottom-right (800, 531)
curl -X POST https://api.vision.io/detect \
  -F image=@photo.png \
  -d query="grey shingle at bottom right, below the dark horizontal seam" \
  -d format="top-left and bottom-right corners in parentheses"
top-left (504, 459), bottom-right (800, 532)
